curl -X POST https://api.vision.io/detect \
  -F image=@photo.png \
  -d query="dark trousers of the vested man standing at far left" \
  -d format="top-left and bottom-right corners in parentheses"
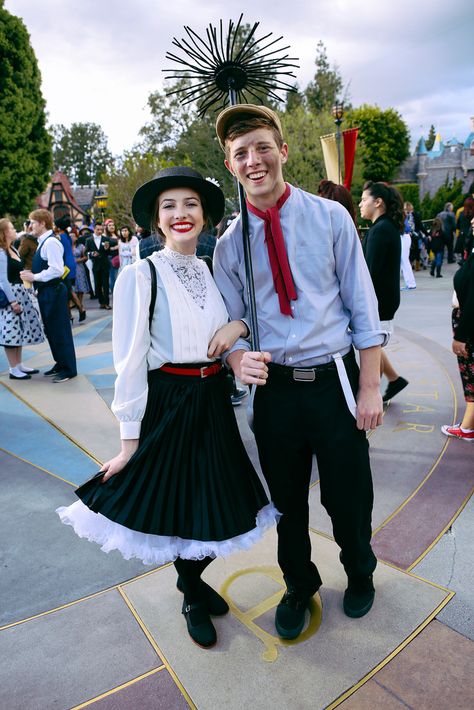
top-left (38, 283), bottom-right (77, 377)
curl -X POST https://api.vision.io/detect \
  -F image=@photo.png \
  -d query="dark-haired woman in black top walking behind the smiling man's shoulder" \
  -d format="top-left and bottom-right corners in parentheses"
top-left (359, 182), bottom-right (408, 402)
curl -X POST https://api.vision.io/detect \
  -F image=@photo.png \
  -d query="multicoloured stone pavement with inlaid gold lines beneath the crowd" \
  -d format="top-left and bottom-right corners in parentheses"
top-left (0, 266), bottom-right (474, 710)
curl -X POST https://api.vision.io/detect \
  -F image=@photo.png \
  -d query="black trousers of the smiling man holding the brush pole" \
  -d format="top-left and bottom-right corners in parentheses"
top-left (254, 354), bottom-right (377, 595)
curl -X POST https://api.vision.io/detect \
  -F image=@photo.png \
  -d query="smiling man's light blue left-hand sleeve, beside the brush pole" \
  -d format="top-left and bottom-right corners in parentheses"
top-left (213, 240), bottom-right (251, 362)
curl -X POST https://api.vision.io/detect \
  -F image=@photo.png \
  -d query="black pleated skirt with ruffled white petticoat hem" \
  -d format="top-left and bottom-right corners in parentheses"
top-left (58, 365), bottom-right (277, 563)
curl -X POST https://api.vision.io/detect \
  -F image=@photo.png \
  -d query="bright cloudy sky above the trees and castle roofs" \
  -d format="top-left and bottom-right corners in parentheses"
top-left (5, 0), bottom-right (474, 154)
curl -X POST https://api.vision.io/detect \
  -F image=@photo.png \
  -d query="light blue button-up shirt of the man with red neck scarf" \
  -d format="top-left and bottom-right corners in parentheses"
top-left (214, 187), bottom-right (387, 367)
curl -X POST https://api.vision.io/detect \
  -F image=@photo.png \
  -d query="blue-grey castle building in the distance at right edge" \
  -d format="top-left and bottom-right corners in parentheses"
top-left (394, 116), bottom-right (474, 198)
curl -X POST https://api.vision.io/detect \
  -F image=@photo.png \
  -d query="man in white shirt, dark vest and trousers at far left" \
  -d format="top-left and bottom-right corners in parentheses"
top-left (20, 209), bottom-right (77, 383)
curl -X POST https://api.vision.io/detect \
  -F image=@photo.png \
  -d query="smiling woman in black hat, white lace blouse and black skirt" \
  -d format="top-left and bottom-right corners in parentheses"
top-left (58, 167), bottom-right (276, 647)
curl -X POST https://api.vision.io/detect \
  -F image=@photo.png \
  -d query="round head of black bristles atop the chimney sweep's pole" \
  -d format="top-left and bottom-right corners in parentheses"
top-left (163, 15), bottom-right (298, 116)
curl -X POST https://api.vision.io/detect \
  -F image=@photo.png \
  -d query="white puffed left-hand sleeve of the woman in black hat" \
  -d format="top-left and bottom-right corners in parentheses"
top-left (112, 261), bottom-right (151, 439)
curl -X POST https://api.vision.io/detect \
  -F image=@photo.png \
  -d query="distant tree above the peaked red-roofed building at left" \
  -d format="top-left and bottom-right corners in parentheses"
top-left (51, 123), bottom-right (113, 185)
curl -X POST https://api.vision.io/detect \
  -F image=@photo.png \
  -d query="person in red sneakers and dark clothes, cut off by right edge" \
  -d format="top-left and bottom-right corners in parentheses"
top-left (441, 218), bottom-right (474, 441)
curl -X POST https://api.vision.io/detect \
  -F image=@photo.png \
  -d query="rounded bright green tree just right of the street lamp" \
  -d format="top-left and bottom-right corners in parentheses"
top-left (346, 104), bottom-right (410, 182)
